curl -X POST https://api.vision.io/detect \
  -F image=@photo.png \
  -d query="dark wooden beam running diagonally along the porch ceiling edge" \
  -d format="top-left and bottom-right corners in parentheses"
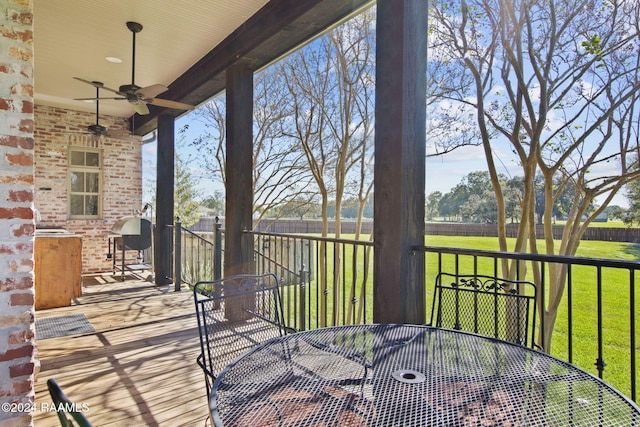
top-left (131, 0), bottom-right (375, 135)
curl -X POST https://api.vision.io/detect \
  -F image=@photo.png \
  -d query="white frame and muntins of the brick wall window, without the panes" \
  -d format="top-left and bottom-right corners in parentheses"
top-left (67, 147), bottom-right (103, 219)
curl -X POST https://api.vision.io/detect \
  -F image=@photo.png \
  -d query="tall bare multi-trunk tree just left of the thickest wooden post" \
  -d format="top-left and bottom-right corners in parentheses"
top-left (278, 9), bottom-right (375, 325)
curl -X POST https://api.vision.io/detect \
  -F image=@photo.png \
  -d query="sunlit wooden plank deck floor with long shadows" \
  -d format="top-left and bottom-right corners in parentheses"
top-left (34, 275), bottom-right (208, 427)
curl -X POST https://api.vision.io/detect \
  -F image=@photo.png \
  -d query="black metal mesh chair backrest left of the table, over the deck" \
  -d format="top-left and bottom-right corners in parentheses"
top-left (193, 273), bottom-right (294, 394)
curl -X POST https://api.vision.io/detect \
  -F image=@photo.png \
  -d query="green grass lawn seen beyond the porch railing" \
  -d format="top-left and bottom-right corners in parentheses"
top-left (285, 236), bottom-right (640, 402)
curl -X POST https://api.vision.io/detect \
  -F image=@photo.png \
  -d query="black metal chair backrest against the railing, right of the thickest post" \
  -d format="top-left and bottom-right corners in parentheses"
top-left (431, 273), bottom-right (537, 347)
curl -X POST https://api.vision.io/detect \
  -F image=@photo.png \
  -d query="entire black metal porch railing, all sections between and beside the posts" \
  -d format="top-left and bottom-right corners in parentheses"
top-left (181, 229), bottom-right (640, 401)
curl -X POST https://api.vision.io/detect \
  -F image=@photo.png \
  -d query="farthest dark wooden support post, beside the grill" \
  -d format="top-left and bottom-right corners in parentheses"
top-left (153, 115), bottom-right (175, 285)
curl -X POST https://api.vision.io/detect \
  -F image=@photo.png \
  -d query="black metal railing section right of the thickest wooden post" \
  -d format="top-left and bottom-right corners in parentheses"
top-left (414, 246), bottom-right (640, 401)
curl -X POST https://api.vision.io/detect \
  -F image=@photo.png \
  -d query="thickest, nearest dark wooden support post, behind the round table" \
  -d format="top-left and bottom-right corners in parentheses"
top-left (373, 0), bottom-right (428, 324)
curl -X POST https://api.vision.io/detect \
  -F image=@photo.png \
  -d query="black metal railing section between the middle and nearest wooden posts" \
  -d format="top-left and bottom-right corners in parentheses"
top-left (247, 232), bottom-right (373, 330)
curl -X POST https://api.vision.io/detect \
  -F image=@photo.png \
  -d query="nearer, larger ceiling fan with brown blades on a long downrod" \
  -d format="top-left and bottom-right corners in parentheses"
top-left (74, 22), bottom-right (195, 115)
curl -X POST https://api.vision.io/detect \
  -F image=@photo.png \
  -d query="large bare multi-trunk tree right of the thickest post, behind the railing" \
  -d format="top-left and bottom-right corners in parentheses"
top-left (430, 0), bottom-right (640, 350)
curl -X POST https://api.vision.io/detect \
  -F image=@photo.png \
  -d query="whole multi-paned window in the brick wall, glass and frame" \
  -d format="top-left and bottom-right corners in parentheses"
top-left (69, 148), bottom-right (102, 219)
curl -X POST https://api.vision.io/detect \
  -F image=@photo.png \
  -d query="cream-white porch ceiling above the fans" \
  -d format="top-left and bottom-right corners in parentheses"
top-left (33, 0), bottom-right (268, 117)
